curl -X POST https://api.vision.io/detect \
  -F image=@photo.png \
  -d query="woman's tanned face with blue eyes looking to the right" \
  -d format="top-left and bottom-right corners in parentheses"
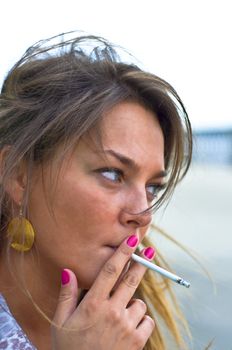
top-left (29, 102), bottom-right (164, 288)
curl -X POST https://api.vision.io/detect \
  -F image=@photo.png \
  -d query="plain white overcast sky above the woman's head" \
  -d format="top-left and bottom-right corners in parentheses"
top-left (0, 0), bottom-right (232, 128)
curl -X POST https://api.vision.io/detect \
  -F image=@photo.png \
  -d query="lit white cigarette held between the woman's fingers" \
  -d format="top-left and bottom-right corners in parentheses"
top-left (131, 254), bottom-right (190, 288)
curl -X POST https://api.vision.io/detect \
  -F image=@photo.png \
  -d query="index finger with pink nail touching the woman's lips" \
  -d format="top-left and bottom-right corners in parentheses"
top-left (86, 235), bottom-right (138, 300)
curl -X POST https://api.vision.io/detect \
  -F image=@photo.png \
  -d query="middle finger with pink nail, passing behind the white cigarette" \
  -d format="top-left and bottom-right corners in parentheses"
top-left (112, 247), bottom-right (155, 308)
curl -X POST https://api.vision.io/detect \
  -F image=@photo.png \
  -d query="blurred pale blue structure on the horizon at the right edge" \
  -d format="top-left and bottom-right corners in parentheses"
top-left (193, 129), bottom-right (232, 165)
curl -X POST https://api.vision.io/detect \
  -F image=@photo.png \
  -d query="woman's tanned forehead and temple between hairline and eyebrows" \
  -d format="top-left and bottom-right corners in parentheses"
top-left (42, 102), bottom-right (165, 182)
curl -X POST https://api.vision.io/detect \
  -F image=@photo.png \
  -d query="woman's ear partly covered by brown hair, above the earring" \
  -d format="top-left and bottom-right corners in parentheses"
top-left (0, 146), bottom-right (27, 205)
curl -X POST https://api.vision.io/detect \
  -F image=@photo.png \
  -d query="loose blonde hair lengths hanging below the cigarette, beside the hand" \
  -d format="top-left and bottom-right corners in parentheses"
top-left (136, 231), bottom-right (191, 350)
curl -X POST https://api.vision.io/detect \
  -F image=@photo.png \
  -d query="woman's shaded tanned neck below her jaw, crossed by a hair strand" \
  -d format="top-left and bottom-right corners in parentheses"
top-left (0, 251), bottom-right (78, 350)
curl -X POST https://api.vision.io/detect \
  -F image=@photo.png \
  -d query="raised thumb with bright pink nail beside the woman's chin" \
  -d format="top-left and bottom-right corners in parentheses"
top-left (53, 269), bottom-right (78, 327)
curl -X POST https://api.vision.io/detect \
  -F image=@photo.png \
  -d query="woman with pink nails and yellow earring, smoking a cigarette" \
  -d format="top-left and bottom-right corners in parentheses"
top-left (0, 31), bottom-right (191, 350)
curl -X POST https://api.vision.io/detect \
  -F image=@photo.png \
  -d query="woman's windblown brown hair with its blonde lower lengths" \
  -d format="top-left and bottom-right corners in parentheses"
top-left (0, 35), bottom-right (192, 350)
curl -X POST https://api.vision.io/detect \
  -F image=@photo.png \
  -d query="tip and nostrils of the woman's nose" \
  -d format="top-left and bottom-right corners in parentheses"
top-left (120, 190), bottom-right (152, 229)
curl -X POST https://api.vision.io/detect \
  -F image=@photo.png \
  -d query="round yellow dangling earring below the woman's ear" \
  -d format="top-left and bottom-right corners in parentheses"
top-left (7, 207), bottom-right (35, 252)
